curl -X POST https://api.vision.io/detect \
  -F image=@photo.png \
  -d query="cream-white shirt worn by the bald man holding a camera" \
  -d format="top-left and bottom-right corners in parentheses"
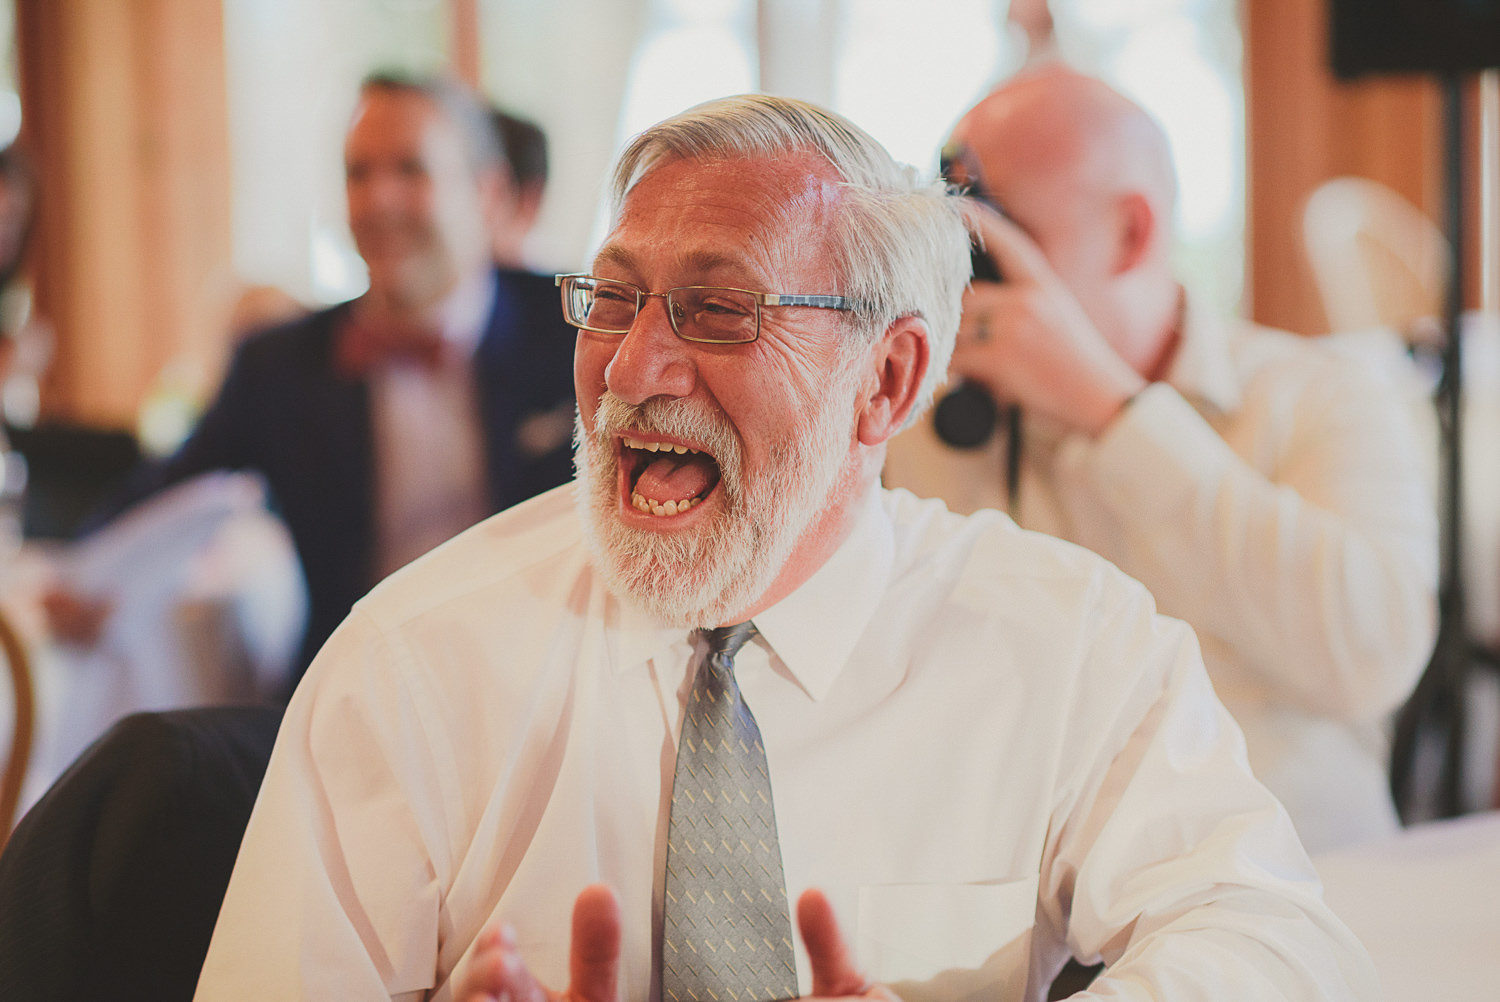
top-left (884, 301), bottom-right (1437, 852)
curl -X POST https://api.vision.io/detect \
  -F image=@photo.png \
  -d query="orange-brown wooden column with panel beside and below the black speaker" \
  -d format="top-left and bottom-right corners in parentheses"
top-left (1244, 0), bottom-right (1442, 333)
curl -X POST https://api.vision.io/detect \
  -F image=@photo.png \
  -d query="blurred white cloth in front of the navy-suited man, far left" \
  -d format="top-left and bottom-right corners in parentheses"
top-left (0, 473), bottom-right (306, 812)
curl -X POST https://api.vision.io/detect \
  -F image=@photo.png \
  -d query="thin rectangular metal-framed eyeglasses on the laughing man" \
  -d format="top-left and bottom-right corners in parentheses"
top-left (557, 275), bottom-right (858, 345)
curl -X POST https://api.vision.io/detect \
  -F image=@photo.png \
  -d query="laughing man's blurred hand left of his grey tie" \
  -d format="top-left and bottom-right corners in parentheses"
top-left (453, 884), bottom-right (621, 1002)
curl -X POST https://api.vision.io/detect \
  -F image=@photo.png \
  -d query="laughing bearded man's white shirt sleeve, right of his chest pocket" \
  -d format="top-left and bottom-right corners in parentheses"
top-left (1032, 579), bottom-right (1379, 1002)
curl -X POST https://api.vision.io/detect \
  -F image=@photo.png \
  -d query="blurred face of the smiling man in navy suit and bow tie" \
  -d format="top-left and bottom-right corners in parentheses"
top-left (344, 89), bottom-right (491, 309)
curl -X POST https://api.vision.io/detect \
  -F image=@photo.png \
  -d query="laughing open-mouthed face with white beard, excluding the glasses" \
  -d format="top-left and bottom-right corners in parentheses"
top-left (575, 156), bottom-right (861, 626)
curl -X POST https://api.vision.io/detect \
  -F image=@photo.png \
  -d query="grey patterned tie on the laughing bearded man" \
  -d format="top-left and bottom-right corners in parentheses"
top-left (662, 623), bottom-right (797, 1002)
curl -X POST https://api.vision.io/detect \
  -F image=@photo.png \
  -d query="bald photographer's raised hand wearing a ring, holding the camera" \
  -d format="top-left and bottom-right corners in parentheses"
top-left (953, 204), bottom-right (1146, 437)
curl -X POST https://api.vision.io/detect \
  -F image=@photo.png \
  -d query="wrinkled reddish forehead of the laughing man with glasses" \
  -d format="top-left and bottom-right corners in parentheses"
top-left (600, 152), bottom-right (845, 285)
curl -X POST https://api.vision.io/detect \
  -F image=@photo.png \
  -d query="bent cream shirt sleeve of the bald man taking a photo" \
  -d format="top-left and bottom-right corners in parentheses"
top-left (1059, 366), bottom-right (1437, 720)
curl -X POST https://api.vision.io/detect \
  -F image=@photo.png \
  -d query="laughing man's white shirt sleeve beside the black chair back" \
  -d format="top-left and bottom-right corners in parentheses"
top-left (197, 611), bottom-right (453, 1002)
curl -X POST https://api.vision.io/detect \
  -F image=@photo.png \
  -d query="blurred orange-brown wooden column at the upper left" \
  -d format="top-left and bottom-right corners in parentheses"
top-left (17, 0), bottom-right (231, 428)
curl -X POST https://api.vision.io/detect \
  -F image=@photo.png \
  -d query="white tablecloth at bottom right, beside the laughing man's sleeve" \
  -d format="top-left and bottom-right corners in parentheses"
top-left (1314, 812), bottom-right (1500, 1002)
